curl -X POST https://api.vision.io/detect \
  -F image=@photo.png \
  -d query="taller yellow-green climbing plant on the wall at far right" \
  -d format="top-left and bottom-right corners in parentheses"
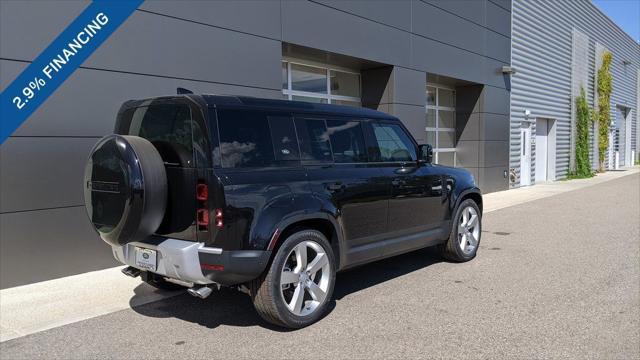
top-left (596, 51), bottom-right (613, 172)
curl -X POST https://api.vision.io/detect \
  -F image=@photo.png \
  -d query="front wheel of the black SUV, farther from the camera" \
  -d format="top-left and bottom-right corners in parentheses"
top-left (441, 199), bottom-right (482, 262)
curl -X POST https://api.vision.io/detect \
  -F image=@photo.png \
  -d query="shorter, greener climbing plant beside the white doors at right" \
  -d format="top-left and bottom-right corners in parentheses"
top-left (570, 87), bottom-right (593, 178)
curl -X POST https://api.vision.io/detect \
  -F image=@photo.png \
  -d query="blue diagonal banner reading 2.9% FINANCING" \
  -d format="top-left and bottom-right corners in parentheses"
top-left (0, 0), bottom-right (143, 144)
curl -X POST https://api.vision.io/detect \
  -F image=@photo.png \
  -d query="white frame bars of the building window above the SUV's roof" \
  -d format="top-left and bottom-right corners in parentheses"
top-left (281, 59), bottom-right (362, 106)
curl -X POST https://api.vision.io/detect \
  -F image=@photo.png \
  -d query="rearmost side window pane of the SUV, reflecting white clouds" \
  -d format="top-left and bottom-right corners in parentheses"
top-left (214, 110), bottom-right (275, 168)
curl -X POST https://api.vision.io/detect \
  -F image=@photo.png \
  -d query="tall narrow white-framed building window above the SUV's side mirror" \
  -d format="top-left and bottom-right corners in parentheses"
top-left (426, 84), bottom-right (457, 166)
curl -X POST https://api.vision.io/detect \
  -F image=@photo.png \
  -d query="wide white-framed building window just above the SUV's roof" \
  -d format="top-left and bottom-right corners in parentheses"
top-left (282, 61), bottom-right (361, 107)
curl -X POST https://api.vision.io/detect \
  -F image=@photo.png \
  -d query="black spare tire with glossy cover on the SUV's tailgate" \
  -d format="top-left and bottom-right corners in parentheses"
top-left (84, 135), bottom-right (167, 245)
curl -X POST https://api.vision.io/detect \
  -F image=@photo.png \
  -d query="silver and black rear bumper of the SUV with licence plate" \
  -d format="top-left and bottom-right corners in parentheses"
top-left (112, 239), bottom-right (271, 286)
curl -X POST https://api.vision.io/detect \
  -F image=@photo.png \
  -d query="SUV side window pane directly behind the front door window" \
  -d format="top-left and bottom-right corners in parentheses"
top-left (327, 120), bottom-right (367, 163)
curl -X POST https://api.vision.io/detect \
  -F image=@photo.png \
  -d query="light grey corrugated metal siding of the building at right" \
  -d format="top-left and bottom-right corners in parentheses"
top-left (509, 0), bottom-right (640, 186)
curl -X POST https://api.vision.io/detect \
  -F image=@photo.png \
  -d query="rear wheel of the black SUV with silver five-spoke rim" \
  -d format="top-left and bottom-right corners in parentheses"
top-left (249, 230), bottom-right (336, 329)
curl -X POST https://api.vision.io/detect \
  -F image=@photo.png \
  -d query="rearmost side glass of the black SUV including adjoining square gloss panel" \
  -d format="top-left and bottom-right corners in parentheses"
top-left (214, 109), bottom-right (300, 168)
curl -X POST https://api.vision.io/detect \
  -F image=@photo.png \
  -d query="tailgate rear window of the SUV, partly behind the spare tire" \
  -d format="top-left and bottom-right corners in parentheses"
top-left (127, 104), bottom-right (194, 167)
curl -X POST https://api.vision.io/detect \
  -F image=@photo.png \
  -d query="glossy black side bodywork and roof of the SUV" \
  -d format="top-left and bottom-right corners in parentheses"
top-left (116, 95), bottom-right (482, 283)
